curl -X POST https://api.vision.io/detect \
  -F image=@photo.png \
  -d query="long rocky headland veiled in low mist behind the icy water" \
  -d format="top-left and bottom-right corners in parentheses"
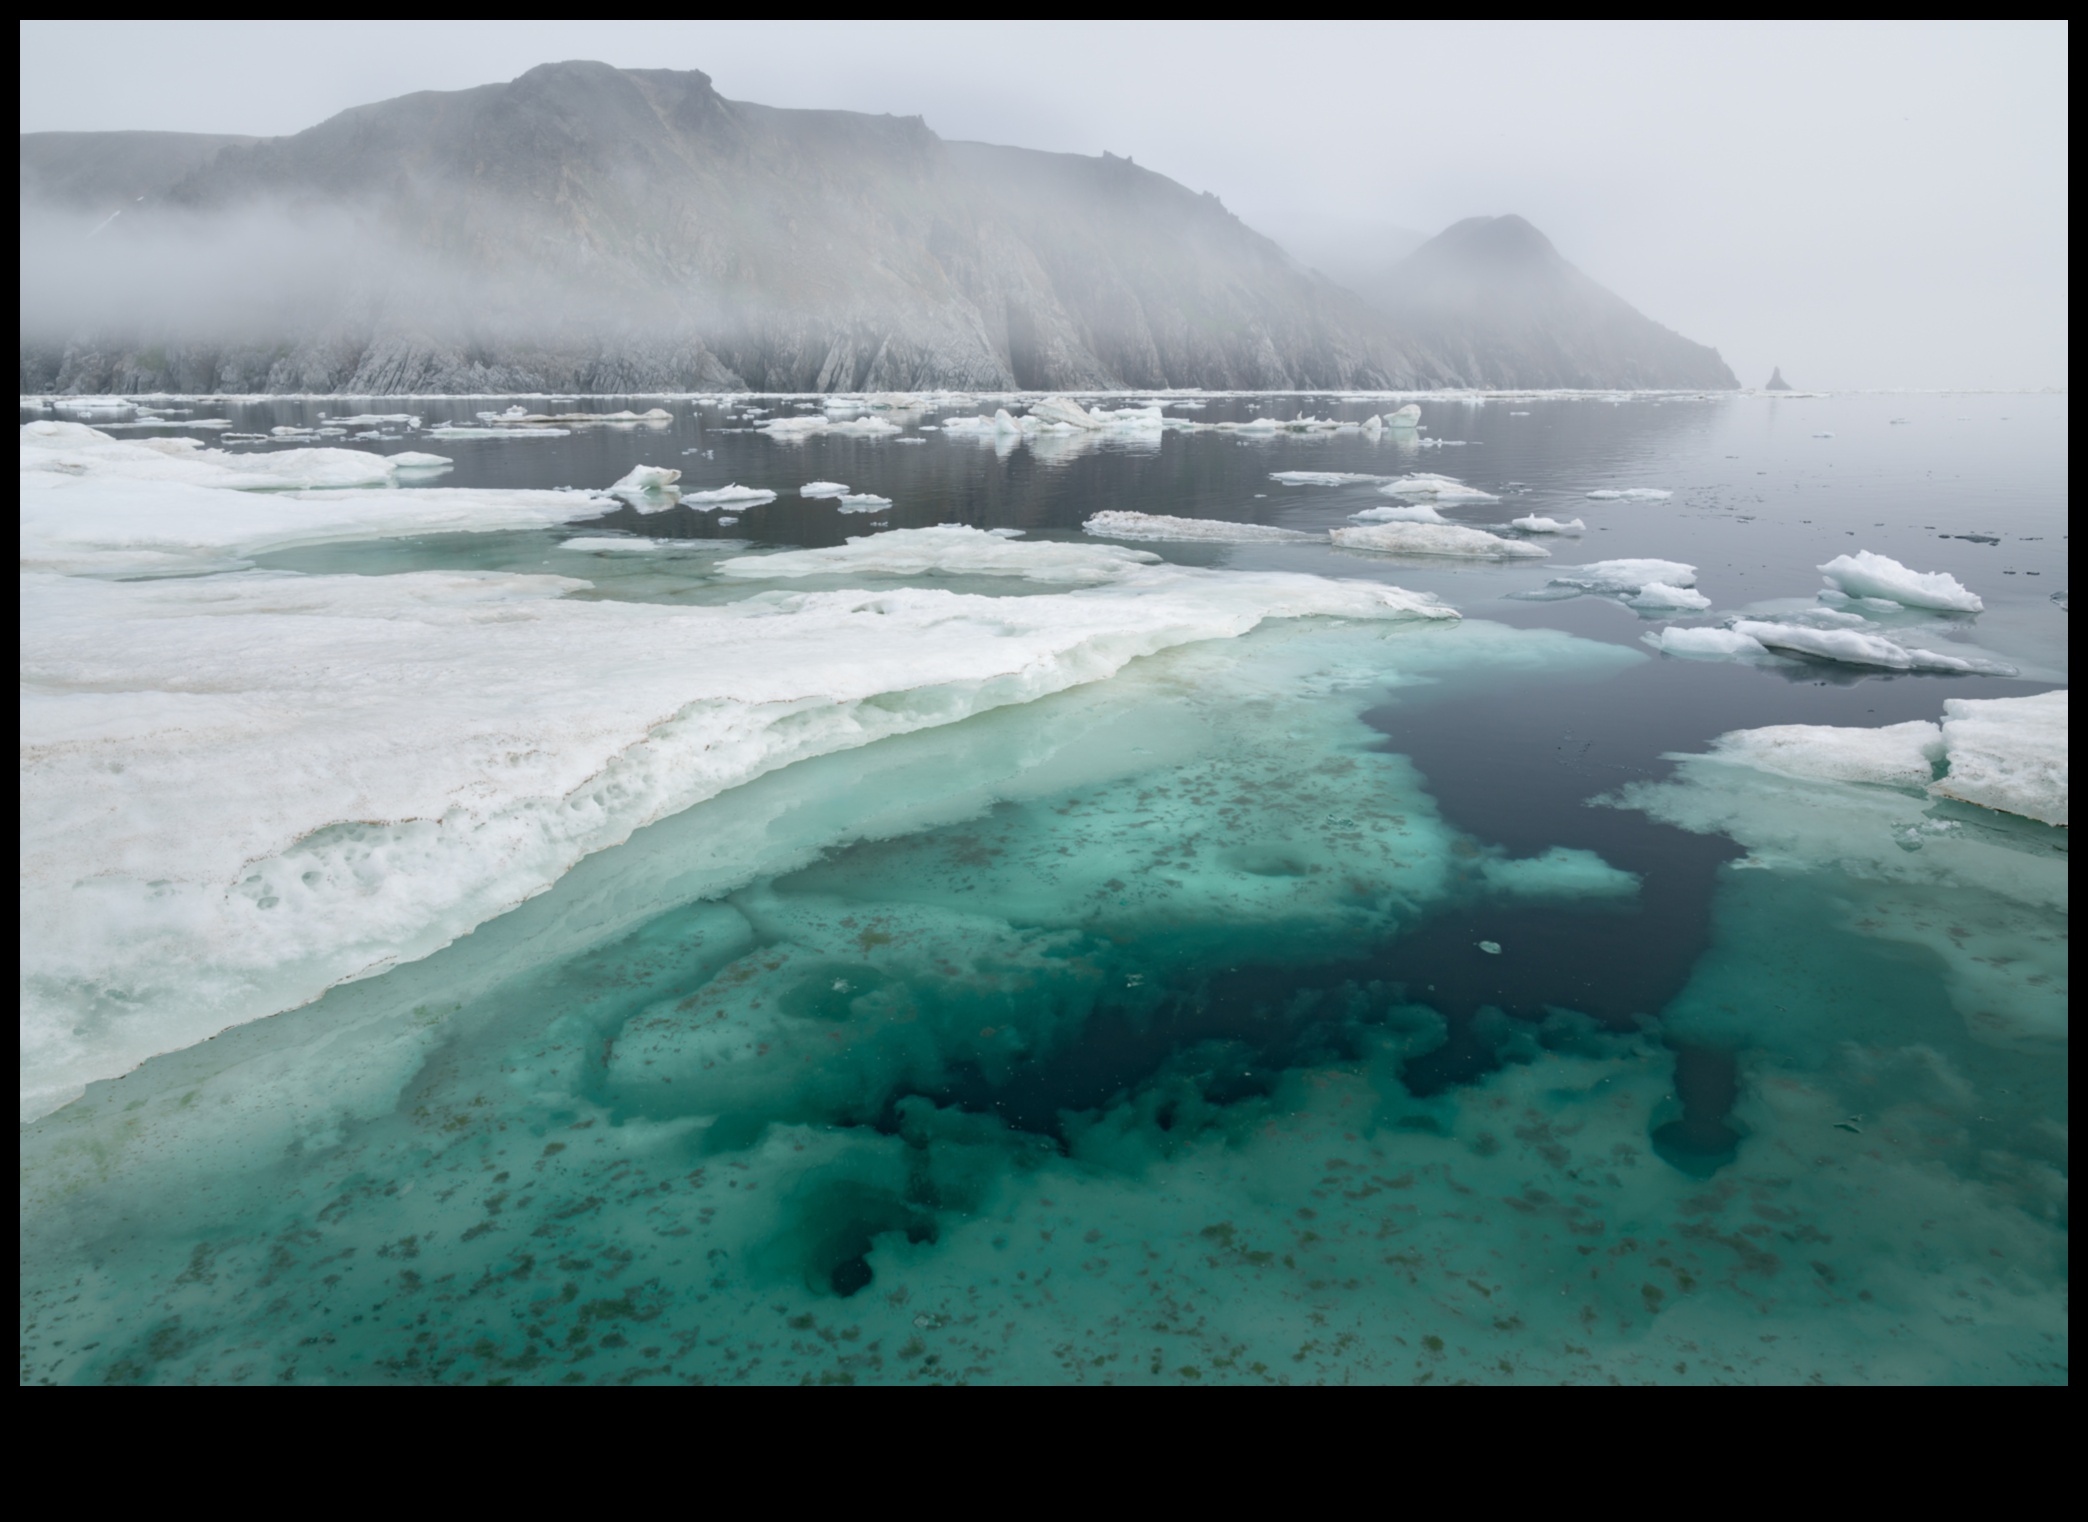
top-left (21, 63), bottom-right (1735, 395)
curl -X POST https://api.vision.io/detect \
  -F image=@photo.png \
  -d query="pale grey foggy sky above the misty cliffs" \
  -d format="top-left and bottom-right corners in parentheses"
top-left (21, 19), bottom-right (2067, 388)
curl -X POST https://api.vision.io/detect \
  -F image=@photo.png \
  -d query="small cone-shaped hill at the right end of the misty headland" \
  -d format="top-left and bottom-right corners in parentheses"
top-left (1363, 217), bottom-right (1739, 388)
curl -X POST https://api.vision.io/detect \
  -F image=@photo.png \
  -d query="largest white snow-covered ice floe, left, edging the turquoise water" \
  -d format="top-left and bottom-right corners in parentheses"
top-left (21, 455), bottom-right (1455, 1117)
